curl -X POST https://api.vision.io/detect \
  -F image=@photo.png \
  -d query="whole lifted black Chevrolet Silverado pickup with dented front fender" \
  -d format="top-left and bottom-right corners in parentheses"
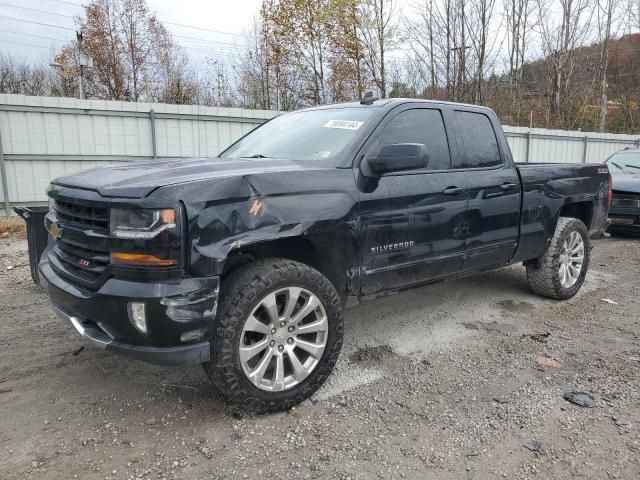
top-left (33, 99), bottom-right (611, 411)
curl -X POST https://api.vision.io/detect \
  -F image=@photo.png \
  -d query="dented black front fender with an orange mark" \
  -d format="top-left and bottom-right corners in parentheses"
top-left (146, 168), bottom-right (359, 276)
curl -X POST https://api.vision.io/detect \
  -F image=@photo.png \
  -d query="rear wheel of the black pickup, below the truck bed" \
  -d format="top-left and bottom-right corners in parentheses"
top-left (527, 217), bottom-right (591, 300)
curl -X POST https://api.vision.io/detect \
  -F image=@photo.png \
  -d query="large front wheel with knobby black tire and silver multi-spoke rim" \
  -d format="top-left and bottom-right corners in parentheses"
top-left (203, 259), bottom-right (343, 412)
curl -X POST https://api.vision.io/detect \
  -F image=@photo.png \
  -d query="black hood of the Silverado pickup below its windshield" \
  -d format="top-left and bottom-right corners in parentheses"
top-left (52, 158), bottom-right (304, 198)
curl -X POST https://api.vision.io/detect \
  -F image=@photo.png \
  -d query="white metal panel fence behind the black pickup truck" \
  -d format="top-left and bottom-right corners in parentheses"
top-left (0, 95), bottom-right (639, 211)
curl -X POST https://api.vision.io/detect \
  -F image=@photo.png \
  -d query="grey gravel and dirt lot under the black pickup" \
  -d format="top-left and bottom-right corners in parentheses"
top-left (0, 233), bottom-right (640, 480)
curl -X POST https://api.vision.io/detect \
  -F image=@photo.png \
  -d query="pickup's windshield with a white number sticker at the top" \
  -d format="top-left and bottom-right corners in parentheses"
top-left (220, 108), bottom-right (374, 165)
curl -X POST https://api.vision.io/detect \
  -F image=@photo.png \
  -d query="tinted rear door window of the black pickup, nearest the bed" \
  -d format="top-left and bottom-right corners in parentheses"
top-left (455, 111), bottom-right (502, 168)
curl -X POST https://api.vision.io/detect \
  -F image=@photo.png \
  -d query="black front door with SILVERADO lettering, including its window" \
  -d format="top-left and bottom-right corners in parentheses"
top-left (356, 104), bottom-right (467, 294)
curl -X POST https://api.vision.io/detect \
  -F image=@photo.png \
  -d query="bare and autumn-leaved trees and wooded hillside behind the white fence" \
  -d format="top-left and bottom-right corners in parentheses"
top-left (0, 0), bottom-right (640, 132)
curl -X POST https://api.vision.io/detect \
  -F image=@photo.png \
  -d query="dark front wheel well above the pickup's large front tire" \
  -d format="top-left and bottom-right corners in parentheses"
top-left (222, 237), bottom-right (349, 299)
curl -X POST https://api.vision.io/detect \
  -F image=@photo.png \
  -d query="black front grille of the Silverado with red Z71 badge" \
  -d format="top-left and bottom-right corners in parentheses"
top-left (49, 199), bottom-right (109, 288)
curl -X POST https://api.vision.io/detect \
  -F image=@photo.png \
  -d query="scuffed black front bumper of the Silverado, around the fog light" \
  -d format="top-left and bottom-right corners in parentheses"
top-left (38, 255), bottom-right (219, 366)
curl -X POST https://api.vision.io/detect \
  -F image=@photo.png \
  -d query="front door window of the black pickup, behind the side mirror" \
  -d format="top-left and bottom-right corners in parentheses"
top-left (372, 108), bottom-right (451, 170)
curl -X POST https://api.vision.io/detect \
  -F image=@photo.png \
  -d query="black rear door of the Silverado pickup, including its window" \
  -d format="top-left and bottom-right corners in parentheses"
top-left (453, 109), bottom-right (521, 271)
